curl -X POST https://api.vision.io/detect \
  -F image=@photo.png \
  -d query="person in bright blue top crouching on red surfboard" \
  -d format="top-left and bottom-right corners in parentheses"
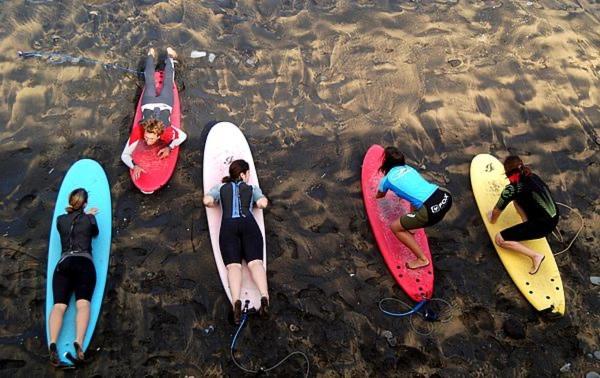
top-left (375, 147), bottom-right (452, 269)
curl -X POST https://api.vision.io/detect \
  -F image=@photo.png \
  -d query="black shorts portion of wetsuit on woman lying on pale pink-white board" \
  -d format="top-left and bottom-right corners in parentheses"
top-left (219, 217), bottom-right (263, 265)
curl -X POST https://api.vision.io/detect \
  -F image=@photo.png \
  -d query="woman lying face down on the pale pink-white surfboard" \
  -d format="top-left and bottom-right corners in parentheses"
top-left (203, 159), bottom-right (269, 324)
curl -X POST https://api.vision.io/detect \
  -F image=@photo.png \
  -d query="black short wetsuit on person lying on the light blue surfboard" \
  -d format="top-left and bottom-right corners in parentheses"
top-left (52, 211), bottom-right (98, 304)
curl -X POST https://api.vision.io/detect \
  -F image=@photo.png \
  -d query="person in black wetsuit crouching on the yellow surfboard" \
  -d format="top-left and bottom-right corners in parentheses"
top-left (488, 155), bottom-right (559, 274)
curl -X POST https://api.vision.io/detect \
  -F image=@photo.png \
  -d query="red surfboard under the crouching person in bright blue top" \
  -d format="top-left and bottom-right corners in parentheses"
top-left (361, 144), bottom-right (433, 302)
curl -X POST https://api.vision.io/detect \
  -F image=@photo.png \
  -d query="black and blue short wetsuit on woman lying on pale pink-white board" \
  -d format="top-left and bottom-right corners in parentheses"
top-left (207, 181), bottom-right (264, 265)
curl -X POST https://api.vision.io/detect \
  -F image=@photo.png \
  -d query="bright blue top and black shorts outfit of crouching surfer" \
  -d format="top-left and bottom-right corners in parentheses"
top-left (378, 165), bottom-right (452, 230)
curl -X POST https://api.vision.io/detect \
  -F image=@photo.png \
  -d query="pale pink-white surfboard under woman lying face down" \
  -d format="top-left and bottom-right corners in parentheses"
top-left (203, 122), bottom-right (267, 310)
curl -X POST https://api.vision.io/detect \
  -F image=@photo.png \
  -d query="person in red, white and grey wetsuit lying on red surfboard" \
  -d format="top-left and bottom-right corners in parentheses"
top-left (121, 47), bottom-right (187, 179)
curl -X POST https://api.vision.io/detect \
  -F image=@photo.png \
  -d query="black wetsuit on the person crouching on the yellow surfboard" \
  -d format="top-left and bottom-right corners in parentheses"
top-left (496, 173), bottom-right (559, 241)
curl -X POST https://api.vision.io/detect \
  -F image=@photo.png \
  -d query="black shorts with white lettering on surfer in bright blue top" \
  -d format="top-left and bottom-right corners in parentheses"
top-left (400, 188), bottom-right (452, 230)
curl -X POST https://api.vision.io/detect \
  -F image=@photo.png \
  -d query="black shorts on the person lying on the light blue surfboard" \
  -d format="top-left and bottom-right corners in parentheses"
top-left (52, 256), bottom-right (96, 305)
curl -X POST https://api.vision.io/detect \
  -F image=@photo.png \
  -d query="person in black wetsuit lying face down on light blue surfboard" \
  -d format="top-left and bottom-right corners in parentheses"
top-left (49, 188), bottom-right (99, 366)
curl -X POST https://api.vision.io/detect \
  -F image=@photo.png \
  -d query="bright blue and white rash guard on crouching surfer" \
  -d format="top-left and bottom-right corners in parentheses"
top-left (378, 165), bottom-right (438, 209)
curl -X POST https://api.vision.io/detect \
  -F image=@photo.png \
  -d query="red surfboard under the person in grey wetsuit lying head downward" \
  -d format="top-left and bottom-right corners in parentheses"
top-left (129, 71), bottom-right (181, 194)
